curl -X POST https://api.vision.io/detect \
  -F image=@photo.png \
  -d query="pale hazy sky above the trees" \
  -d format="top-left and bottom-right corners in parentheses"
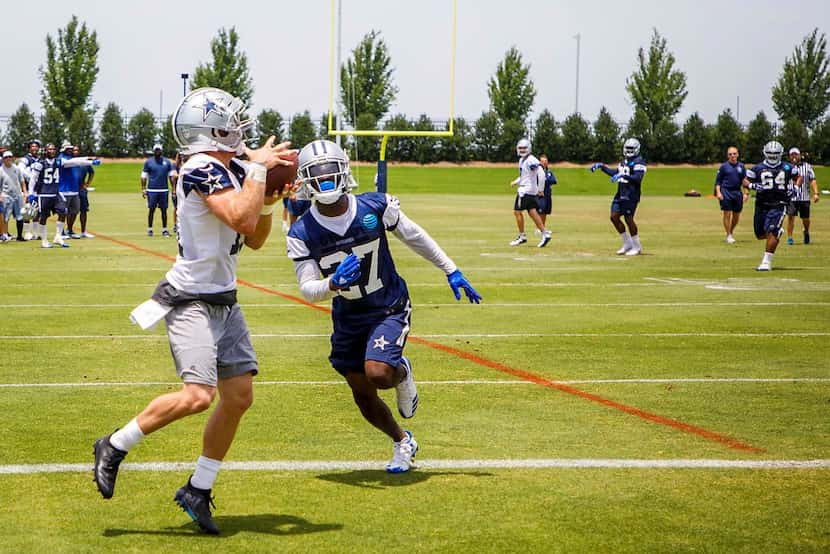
top-left (0, 0), bottom-right (830, 123)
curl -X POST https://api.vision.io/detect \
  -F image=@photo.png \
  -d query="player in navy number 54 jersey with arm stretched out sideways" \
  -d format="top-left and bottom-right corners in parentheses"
top-left (29, 143), bottom-right (101, 248)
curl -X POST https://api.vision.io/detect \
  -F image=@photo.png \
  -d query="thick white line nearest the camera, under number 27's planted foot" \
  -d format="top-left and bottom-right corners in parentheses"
top-left (0, 458), bottom-right (830, 475)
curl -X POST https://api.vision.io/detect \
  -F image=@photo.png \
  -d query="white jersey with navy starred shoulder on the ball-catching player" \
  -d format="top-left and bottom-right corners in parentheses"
top-left (166, 154), bottom-right (246, 294)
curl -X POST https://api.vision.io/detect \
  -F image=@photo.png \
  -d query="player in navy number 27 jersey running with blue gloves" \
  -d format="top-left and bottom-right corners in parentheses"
top-left (287, 140), bottom-right (481, 473)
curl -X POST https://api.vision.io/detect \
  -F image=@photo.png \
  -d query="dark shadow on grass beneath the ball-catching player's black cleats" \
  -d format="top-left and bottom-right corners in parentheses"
top-left (103, 514), bottom-right (343, 539)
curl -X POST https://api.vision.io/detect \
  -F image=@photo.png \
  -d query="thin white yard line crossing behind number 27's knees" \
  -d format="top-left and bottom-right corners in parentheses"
top-left (0, 377), bottom-right (830, 389)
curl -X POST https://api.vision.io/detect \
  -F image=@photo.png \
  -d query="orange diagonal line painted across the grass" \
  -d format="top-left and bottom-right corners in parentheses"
top-left (91, 231), bottom-right (764, 453)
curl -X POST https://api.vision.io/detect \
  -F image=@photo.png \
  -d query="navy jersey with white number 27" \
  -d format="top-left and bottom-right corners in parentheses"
top-left (288, 192), bottom-right (409, 318)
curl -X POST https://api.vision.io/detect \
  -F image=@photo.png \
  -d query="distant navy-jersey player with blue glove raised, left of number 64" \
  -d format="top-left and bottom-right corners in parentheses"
top-left (591, 138), bottom-right (646, 256)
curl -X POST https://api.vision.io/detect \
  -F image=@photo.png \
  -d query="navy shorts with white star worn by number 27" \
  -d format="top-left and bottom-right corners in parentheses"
top-left (329, 300), bottom-right (412, 376)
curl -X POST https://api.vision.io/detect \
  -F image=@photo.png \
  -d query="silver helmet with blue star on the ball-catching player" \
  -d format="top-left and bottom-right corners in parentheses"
top-left (171, 88), bottom-right (254, 155)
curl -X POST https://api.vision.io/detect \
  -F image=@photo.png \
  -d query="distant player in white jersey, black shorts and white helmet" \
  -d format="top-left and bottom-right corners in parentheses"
top-left (510, 139), bottom-right (550, 248)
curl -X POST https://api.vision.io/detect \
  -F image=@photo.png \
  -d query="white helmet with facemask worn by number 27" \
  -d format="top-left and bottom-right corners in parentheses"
top-left (297, 140), bottom-right (357, 204)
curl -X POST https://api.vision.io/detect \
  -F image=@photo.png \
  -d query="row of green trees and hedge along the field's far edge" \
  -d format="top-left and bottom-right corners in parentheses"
top-left (3, 16), bottom-right (830, 164)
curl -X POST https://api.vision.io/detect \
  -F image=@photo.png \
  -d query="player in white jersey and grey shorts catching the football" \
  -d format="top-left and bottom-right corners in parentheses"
top-left (93, 88), bottom-right (293, 534)
